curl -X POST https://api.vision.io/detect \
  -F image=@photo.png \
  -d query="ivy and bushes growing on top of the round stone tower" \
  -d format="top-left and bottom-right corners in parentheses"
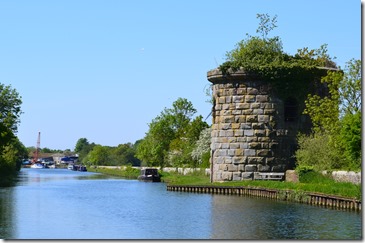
top-left (219, 14), bottom-right (336, 100)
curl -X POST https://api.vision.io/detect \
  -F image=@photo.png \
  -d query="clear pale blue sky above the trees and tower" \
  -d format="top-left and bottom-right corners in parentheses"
top-left (0, 0), bottom-right (361, 150)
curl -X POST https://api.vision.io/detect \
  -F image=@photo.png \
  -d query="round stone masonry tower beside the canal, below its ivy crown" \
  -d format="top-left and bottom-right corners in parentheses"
top-left (207, 69), bottom-right (328, 182)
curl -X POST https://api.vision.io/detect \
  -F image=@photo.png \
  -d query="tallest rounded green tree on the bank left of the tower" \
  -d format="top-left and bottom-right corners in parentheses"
top-left (136, 98), bottom-right (208, 168)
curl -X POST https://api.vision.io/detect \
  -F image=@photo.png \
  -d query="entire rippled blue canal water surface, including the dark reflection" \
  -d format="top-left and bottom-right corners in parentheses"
top-left (0, 169), bottom-right (362, 240)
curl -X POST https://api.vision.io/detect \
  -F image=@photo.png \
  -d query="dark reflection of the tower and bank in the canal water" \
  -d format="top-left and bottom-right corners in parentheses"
top-left (212, 195), bottom-right (362, 240)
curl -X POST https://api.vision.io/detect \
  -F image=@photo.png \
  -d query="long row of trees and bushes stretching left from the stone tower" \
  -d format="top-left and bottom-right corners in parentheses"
top-left (74, 98), bottom-right (210, 168)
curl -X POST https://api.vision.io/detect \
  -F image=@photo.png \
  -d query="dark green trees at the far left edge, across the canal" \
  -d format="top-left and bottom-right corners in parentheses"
top-left (0, 84), bottom-right (27, 186)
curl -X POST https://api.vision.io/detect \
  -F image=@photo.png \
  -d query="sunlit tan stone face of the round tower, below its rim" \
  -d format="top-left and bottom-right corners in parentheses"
top-left (211, 82), bottom-right (285, 181)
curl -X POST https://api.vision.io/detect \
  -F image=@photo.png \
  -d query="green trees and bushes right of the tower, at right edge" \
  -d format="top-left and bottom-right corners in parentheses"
top-left (296, 59), bottom-right (361, 170)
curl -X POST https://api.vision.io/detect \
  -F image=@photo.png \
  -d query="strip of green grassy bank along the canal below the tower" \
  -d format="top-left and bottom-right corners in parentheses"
top-left (88, 167), bottom-right (362, 200)
